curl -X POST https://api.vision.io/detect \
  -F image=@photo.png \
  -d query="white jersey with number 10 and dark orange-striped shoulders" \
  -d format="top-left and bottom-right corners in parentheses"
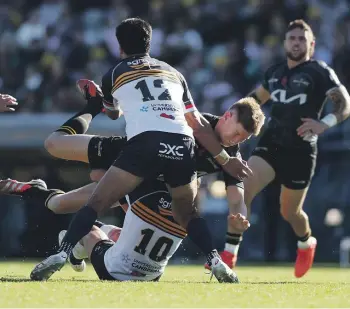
top-left (104, 191), bottom-right (186, 281)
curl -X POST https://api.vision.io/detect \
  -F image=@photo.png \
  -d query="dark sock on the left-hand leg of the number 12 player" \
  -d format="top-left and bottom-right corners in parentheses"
top-left (58, 206), bottom-right (97, 255)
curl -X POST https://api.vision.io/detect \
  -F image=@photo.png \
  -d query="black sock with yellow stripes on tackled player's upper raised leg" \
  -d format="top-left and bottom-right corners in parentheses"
top-left (56, 97), bottom-right (103, 135)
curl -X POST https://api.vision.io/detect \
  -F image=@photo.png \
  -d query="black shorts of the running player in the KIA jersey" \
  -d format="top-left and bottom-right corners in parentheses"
top-left (252, 136), bottom-right (317, 190)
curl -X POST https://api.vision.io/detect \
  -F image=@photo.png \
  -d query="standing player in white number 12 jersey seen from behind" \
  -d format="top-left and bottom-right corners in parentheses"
top-left (31, 18), bottom-right (251, 282)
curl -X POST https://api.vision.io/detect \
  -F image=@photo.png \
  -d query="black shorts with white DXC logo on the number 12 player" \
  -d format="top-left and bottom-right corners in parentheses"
top-left (113, 131), bottom-right (196, 188)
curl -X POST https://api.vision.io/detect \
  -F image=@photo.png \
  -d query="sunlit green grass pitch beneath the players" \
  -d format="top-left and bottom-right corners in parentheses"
top-left (0, 262), bottom-right (350, 308)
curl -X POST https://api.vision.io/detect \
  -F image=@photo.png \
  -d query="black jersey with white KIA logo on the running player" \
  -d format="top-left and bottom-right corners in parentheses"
top-left (262, 60), bottom-right (341, 147)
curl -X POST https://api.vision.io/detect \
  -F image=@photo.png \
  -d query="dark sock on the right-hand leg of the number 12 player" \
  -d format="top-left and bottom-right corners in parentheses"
top-left (187, 218), bottom-right (214, 256)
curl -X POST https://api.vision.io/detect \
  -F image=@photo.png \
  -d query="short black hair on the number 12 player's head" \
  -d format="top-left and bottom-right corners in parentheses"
top-left (115, 18), bottom-right (152, 55)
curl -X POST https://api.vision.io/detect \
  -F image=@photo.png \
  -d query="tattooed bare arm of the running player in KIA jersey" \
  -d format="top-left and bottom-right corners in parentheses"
top-left (327, 86), bottom-right (350, 122)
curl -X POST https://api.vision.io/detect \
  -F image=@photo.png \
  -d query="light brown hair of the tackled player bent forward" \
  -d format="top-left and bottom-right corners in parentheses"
top-left (230, 97), bottom-right (265, 136)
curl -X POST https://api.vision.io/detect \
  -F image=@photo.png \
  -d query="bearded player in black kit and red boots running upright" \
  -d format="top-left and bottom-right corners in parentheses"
top-left (213, 20), bottom-right (350, 278)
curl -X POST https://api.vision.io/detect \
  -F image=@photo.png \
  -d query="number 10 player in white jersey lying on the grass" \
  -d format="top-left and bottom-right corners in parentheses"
top-left (60, 180), bottom-right (194, 281)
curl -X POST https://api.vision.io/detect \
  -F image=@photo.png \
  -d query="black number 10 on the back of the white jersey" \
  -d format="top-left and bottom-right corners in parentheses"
top-left (134, 229), bottom-right (174, 262)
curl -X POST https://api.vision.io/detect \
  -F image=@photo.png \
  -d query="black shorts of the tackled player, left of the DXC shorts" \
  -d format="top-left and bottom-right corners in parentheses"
top-left (88, 136), bottom-right (127, 170)
